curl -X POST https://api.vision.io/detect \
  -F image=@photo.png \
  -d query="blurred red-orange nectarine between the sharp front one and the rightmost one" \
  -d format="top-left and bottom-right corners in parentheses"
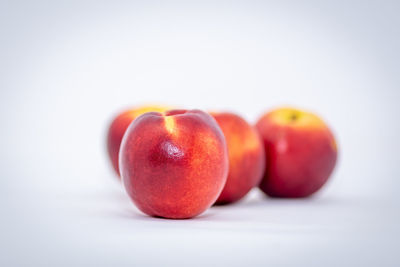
top-left (211, 112), bottom-right (265, 205)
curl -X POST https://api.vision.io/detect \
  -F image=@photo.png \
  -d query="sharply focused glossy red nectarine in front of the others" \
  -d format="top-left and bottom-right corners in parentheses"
top-left (119, 110), bottom-right (229, 219)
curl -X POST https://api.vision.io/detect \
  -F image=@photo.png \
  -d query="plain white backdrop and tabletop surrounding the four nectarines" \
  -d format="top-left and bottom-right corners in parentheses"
top-left (0, 0), bottom-right (400, 266)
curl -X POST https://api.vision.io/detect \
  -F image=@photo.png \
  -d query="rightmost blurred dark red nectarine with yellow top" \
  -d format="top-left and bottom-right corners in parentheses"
top-left (256, 108), bottom-right (337, 198)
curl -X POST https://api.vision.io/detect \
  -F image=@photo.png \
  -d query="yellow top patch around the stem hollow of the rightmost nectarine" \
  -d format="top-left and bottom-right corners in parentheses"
top-left (269, 108), bottom-right (325, 128)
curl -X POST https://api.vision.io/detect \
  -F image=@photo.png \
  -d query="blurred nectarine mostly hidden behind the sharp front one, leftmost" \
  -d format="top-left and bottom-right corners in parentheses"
top-left (107, 106), bottom-right (168, 175)
